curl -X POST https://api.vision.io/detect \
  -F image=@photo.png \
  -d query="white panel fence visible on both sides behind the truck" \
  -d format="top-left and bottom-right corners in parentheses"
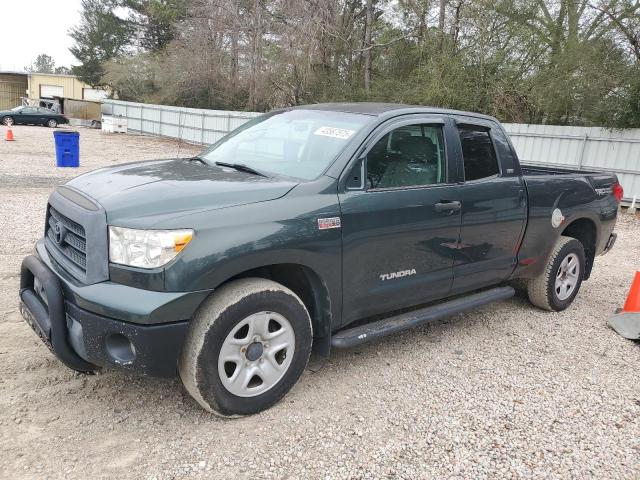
top-left (102, 99), bottom-right (640, 199)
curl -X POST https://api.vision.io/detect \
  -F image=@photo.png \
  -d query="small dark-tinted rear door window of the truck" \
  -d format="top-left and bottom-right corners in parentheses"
top-left (459, 126), bottom-right (500, 182)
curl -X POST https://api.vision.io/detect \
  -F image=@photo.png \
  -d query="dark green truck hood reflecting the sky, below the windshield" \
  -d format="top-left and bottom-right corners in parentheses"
top-left (67, 159), bottom-right (297, 226)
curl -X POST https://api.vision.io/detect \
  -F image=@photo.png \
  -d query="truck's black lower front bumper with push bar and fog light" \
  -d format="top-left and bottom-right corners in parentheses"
top-left (20, 255), bottom-right (189, 377)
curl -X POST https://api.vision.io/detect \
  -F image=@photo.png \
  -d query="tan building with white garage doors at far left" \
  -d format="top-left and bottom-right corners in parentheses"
top-left (0, 72), bottom-right (107, 110)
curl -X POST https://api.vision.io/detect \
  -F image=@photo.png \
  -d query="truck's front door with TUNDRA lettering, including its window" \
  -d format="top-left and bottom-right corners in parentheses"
top-left (339, 116), bottom-right (460, 325)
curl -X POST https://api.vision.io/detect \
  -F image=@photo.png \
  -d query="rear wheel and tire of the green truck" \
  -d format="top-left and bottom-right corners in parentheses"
top-left (527, 236), bottom-right (585, 312)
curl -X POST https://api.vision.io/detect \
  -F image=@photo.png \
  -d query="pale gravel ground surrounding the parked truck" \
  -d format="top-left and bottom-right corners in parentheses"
top-left (0, 127), bottom-right (640, 479)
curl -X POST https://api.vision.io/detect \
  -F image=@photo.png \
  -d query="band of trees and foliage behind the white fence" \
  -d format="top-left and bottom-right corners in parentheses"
top-left (74, 0), bottom-right (640, 127)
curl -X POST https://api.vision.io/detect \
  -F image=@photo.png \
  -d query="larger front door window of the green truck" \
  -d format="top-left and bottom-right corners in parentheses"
top-left (367, 125), bottom-right (446, 188)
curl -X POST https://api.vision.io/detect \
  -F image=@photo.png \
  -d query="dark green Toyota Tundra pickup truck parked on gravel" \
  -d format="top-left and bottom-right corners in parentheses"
top-left (20, 103), bottom-right (622, 415)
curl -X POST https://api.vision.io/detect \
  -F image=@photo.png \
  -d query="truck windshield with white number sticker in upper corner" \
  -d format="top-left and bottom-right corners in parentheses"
top-left (200, 110), bottom-right (371, 180)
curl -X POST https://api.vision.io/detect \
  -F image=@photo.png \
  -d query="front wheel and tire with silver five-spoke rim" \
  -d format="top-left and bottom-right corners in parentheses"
top-left (178, 278), bottom-right (313, 417)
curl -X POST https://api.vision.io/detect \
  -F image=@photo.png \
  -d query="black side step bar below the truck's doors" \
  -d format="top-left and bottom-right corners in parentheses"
top-left (331, 287), bottom-right (515, 348)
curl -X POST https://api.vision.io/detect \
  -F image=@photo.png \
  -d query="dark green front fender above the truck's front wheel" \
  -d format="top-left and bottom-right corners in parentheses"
top-left (163, 186), bottom-right (342, 319)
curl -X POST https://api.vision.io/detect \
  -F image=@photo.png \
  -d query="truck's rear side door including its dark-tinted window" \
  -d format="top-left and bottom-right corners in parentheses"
top-left (451, 119), bottom-right (527, 294)
